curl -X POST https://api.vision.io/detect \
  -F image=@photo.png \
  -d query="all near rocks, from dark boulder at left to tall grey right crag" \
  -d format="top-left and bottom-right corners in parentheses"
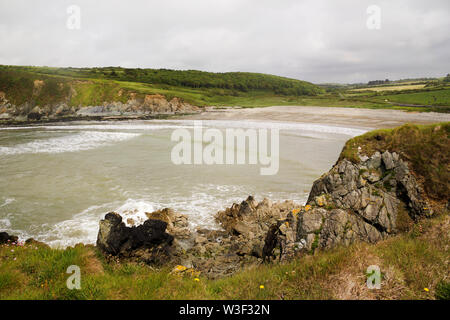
top-left (93, 151), bottom-right (432, 278)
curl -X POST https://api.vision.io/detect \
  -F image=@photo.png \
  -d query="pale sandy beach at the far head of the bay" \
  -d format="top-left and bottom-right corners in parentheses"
top-left (179, 106), bottom-right (450, 128)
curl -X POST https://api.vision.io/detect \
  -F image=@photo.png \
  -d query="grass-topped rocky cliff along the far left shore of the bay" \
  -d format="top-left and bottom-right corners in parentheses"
top-left (0, 80), bottom-right (201, 122)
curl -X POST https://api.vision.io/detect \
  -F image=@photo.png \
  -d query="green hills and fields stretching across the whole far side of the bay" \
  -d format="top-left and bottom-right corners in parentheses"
top-left (0, 66), bottom-right (450, 112)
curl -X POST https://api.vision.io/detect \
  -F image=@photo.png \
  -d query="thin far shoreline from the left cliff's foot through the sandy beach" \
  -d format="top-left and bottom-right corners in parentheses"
top-left (0, 106), bottom-right (450, 130)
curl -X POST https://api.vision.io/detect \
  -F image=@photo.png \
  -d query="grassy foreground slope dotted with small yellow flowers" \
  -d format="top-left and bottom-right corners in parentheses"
top-left (0, 214), bottom-right (450, 300)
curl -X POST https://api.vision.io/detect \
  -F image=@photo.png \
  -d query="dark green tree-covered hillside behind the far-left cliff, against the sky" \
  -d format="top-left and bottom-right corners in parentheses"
top-left (0, 66), bottom-right (323, 105)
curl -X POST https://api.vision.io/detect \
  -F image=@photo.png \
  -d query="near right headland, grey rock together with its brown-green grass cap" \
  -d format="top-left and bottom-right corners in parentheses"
top-left (297, 123), bottom-right (450, 254)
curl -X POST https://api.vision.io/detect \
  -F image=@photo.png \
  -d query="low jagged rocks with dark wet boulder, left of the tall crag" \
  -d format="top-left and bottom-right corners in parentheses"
top-left (97, 196), bottom-right (304, 278)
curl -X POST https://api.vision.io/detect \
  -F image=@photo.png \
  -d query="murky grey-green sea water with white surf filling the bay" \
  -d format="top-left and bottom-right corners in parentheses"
top-left (0, 120), bottom-right (367, 247)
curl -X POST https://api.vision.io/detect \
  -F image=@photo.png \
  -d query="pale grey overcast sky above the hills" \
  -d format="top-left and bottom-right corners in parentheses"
top-left (0, 0), bottom-right (450, 83)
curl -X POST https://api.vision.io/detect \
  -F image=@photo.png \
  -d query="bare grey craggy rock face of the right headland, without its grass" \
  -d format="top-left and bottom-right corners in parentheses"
top-left (297, 151), bottom-right (432, 249)
